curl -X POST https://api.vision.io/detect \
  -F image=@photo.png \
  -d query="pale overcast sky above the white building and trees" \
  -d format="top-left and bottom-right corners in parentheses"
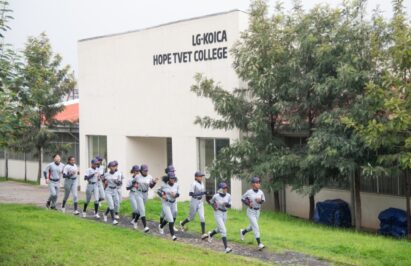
top-left (6, 0), bottom-right (411, 75)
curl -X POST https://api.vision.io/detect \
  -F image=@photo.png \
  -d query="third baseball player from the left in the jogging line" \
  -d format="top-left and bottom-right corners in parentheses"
top-left (83, 159), bottom-right (100, 219)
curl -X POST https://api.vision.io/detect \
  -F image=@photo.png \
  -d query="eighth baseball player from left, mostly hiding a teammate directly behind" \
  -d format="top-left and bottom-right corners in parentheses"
top-left (157, 172), bottom-right (180, 241)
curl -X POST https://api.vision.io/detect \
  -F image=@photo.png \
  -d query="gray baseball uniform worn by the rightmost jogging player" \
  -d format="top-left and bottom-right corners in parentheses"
top-left (241, 189), bottom-right (265, 238)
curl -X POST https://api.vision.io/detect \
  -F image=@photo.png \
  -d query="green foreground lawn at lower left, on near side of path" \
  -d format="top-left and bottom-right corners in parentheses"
top-left (0, 204), bottom-right (263, 265)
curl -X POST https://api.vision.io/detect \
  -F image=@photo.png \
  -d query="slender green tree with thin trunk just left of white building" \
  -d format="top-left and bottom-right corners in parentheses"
top-left (23, 33), bottom-right (76, 183)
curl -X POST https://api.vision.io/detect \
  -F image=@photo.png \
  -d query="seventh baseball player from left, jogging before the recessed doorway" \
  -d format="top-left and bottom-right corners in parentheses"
top-left (134, 164), bottom-right (158, 233)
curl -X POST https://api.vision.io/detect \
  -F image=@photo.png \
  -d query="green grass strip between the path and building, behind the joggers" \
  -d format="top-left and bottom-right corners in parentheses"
top-left (98, 199), bottom-right (411, 265)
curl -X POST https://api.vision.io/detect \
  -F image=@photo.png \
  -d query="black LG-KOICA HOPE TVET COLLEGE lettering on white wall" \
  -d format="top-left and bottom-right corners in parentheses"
top-left (153, 30), bottom-right (228, 66)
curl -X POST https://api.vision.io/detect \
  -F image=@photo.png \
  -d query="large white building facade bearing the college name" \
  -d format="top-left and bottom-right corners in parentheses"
top-left (78, 11), bottom-right (248, 206)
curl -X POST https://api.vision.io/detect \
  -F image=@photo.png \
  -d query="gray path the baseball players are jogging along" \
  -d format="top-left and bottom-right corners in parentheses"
top-left (0, 182), bottom-right (329, 266)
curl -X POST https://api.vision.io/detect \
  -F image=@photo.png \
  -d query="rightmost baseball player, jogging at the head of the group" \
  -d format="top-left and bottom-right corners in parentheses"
top-left (240, 176), bottom-right (265, 250)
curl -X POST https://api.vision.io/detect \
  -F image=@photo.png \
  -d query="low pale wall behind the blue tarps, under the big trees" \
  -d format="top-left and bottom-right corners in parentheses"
top-left (286, 187), bottom-right (406, 229)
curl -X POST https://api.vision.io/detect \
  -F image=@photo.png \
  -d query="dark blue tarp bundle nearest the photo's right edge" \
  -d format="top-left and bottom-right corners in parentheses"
top-left (378, 208), bottom-right (407, 237)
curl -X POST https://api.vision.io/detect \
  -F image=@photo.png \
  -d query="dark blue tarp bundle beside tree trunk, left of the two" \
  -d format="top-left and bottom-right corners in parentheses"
top-left (314, 199), bottom-right (351, 227)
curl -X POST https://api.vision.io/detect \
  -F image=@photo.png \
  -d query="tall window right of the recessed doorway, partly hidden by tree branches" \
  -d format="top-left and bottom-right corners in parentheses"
top-left (197, 138), bottom-right (231, 193)
